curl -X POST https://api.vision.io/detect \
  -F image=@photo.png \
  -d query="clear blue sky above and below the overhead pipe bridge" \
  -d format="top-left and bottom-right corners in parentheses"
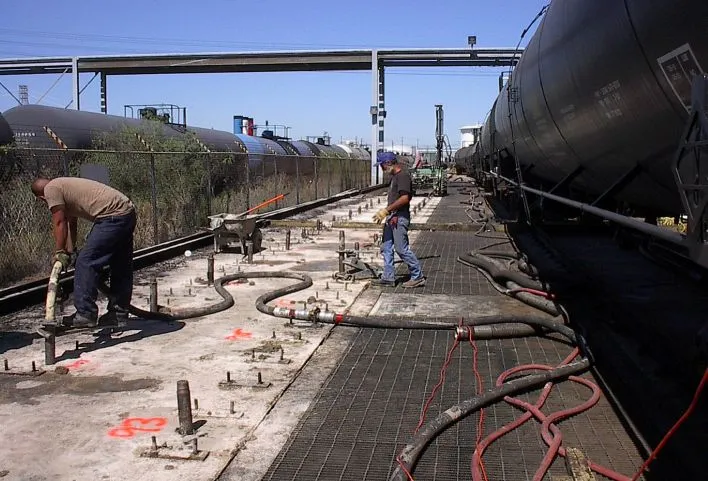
top-left (0, 0), bottom-right (548, 147)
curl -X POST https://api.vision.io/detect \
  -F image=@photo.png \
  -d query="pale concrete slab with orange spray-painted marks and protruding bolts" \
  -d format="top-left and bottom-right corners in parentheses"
top-left (0, 191), bottom-right (396, 481)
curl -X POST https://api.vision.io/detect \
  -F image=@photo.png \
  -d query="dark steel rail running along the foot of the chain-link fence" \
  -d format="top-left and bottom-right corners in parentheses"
top-left (0, 184), bottom-right (385, 315)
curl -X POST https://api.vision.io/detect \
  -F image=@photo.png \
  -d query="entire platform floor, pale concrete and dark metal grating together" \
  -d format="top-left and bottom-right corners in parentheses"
top-left (0, 183), bottom-right (696, 481)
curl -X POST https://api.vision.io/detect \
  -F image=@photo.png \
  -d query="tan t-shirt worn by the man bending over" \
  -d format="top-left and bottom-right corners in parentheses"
top-left (44, 177), bottom-right (135, 222)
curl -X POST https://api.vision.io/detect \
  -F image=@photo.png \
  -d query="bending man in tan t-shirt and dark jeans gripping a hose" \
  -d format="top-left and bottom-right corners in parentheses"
top-left (32, 177), bottom-right (136, 327)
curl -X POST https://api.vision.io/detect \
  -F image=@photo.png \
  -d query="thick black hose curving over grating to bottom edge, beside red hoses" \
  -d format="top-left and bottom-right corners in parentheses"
top-left (390, 359), bottom-right (590, 481)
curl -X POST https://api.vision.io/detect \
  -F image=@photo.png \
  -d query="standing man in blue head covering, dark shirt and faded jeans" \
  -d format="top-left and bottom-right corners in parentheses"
top-left (372, 152), bottom-right (425, 287)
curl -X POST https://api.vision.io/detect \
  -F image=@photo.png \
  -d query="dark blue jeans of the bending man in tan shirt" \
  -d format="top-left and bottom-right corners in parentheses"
top-left (74, 212), bottom-right (135, 318)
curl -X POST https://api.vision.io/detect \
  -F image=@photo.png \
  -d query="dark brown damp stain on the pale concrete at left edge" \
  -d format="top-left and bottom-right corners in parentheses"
top-left (0, 372), bottom-right (162, 404)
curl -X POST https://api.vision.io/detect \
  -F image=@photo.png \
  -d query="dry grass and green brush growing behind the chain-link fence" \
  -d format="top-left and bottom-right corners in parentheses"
top-left (0, 147), bottom-right (369, 288)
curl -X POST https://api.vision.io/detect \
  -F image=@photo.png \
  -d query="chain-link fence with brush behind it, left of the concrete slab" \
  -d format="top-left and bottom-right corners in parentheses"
top-left (0, 144), bottom-right (370, 288)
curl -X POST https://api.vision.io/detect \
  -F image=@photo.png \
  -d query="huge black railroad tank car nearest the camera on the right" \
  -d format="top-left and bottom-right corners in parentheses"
top-left (476, 0), bottom-right (708, 215)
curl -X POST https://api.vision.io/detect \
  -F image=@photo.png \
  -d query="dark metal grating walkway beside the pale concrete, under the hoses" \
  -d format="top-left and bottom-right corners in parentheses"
top-left (263, 188), bottom-right (642, 481)
